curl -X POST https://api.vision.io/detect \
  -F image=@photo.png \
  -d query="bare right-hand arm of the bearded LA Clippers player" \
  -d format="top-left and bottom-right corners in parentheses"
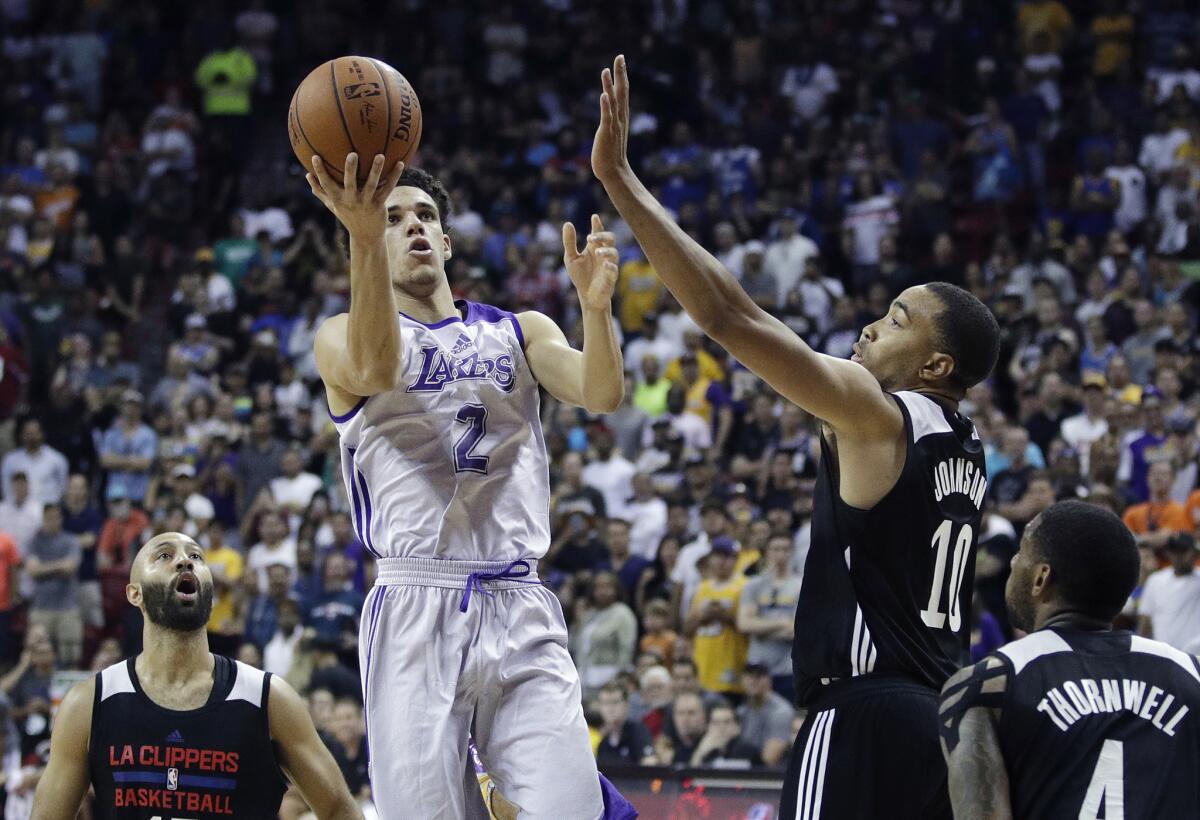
top-left (266, 675), bottom-right (362, 820)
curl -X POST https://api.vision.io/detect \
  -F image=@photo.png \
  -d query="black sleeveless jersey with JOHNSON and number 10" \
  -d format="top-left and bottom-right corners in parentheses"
top-left (792, 391), bottom-right (988, 705)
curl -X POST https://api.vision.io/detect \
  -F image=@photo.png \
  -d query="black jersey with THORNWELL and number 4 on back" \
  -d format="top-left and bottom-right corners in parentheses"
top-left (984, 628), bottom-right (1200, 820)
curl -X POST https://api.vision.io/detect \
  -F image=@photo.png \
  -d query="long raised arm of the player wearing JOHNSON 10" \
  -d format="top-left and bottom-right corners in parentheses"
top-left (592, 56), bottom-right (904, 438)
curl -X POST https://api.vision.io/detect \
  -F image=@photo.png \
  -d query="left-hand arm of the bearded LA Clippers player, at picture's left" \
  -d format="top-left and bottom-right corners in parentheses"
top-left (31, 678), bottom-right (96, 820)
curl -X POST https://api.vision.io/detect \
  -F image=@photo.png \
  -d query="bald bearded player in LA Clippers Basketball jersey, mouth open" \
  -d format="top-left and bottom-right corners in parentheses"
top-left (32, 532), bottom-right (362, 820)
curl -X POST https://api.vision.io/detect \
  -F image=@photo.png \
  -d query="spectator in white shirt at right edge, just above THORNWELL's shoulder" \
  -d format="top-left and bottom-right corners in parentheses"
top-left (1138, 532), bottom-right (1200, 654)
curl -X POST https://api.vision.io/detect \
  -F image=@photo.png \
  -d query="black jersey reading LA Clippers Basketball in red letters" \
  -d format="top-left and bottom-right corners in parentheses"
top-left (88, 656), bottom-right (287, 820)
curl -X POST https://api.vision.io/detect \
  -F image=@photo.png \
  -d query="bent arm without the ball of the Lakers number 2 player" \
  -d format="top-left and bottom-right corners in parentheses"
top-left (517, 214), bottom-right (625, 413)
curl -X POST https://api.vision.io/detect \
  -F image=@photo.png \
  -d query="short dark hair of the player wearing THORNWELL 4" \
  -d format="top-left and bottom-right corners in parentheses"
top-left (1030, 501), bottom-right (1141, 621)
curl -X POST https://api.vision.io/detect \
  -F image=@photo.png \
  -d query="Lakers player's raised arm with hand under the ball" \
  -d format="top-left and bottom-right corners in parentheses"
top-left (307, 154), bottom-right (404, 400)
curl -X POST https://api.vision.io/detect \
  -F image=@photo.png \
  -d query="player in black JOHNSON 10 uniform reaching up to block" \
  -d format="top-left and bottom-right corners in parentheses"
top-left (592, 56), bottom-right (998, 820)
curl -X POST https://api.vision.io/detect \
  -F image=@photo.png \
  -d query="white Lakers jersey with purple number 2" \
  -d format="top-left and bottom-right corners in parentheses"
top-left (332, 300), bottom-right (550, 561)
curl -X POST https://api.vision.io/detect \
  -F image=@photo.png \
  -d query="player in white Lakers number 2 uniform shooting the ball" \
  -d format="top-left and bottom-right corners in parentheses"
top-left (308, 154), bottom-right (624, 820)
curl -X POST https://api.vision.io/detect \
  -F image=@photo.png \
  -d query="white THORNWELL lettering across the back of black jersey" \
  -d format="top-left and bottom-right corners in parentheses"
top-left (1038, 677), bottom-right (1188, 737)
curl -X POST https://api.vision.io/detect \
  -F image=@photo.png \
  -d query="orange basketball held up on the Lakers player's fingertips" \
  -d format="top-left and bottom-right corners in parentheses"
top-left (288, 56), bottom-right (421, 185)
